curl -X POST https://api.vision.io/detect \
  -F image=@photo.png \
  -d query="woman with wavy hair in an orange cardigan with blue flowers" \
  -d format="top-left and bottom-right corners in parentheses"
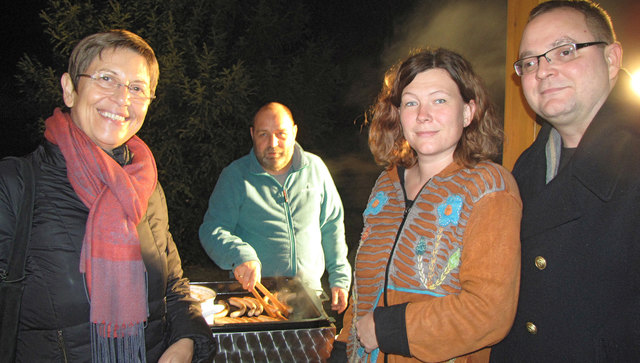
top-left (332, 49), bottom-right (522, 362)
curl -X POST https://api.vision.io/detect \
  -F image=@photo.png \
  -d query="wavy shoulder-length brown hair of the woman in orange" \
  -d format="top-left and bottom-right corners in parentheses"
top-left (365, 48), bottom-right (503, 169)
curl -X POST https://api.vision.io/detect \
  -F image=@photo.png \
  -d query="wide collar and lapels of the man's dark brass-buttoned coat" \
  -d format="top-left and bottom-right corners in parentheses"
top-left (514, 73), bottom-right (640, 239)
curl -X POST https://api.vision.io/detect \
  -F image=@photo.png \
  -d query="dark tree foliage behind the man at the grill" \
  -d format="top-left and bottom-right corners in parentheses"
top-left (17, 0), bottom-right (344, 264)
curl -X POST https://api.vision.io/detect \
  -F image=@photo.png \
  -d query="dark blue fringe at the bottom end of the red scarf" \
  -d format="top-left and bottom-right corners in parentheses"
top-left (90, 323), bottom-right (147, 363)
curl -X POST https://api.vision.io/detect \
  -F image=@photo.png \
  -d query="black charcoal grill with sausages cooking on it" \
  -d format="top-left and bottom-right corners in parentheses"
top-left (192, 277), bottom-right (336, 363)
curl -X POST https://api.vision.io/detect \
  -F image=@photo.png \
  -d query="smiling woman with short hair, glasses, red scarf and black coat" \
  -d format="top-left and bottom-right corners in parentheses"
top-left (0, 30), bottom-right (213, 362)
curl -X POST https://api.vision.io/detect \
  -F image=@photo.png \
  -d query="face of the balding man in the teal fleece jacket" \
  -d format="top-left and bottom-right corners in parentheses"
top-left (251, 108), bottom-right (298, 175)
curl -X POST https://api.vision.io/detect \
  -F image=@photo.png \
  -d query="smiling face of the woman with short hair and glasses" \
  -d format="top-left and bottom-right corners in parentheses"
top-left (61, 48), bottom-right (150, 152)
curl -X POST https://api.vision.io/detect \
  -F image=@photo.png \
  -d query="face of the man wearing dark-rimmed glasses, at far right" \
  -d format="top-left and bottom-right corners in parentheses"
top-left (519, 8), bottom-right (621, 139)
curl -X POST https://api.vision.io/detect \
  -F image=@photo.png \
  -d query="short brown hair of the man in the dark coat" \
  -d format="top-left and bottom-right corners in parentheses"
top-left (528, 0), bottom-right (616, 44)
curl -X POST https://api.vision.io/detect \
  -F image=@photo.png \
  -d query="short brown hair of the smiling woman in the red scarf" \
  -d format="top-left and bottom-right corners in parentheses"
top-left (68, 29), bottom-right (160, 93)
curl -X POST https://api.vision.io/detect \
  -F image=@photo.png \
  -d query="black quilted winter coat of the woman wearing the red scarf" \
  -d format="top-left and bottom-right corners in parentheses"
top-left (0, 142), bottom-right (214, 362)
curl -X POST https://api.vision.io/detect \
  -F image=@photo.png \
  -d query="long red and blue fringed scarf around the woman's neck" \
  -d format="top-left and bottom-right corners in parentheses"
top-left (45, 109), bottom-right (158, 362)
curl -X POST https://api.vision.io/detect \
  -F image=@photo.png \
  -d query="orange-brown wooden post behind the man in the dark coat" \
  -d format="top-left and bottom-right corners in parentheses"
top-left (502, 0), bottom-right (542, 170)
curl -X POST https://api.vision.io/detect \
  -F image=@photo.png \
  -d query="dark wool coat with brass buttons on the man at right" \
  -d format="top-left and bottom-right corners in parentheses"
top-left (491, 72), bottom-right (640, 362)
